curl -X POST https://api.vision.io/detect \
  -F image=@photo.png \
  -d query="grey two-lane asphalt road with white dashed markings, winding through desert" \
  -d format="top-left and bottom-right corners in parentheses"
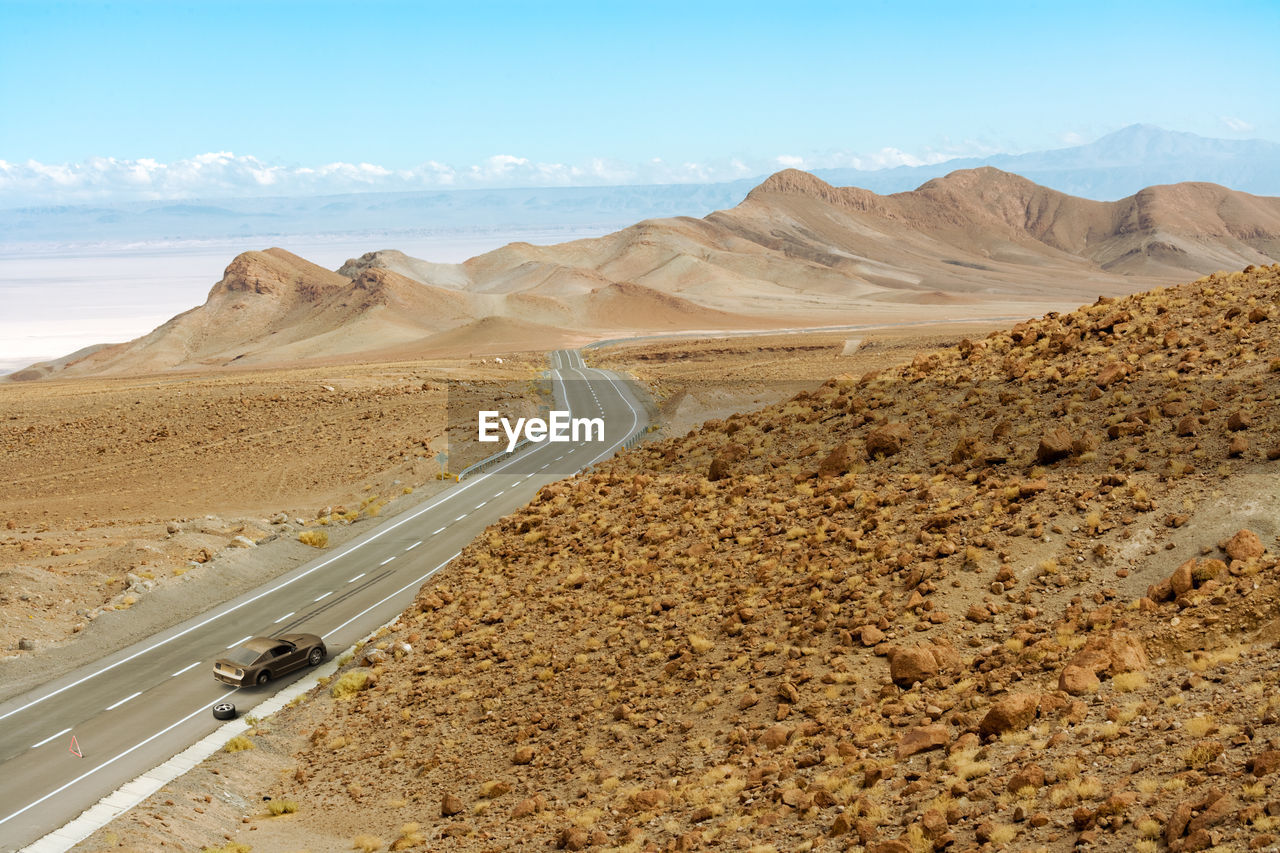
top-left (0, 350), bottom-right (646, 850)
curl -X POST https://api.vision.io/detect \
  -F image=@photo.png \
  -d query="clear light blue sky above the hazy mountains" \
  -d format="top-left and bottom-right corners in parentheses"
top-left (0, 0), bottom-right (1280, 197)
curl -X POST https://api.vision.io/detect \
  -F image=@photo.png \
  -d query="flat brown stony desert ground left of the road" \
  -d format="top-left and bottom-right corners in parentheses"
top-left (0, 353), bottom-right (545, 692)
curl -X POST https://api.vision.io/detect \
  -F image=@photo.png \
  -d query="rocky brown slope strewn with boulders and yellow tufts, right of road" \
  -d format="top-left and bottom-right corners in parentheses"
top-left (82, 265), bottom-right (1280, 853)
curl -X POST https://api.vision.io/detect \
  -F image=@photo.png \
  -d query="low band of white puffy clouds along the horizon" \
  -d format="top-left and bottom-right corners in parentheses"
top-left (0, 145), bottom-right (998, 206)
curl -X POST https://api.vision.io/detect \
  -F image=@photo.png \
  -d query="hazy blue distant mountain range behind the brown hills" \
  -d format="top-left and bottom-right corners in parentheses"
top-left (0, 124), bottom-right (1280, 248)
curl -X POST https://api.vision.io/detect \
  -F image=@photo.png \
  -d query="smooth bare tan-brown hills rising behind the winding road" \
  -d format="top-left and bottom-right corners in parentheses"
top-left (15, 168), bottom-right (1280, 379)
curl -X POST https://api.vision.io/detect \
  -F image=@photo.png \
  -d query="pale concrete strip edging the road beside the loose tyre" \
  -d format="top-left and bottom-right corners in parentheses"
top-left (20, 613), bottom-right (401, 853)
